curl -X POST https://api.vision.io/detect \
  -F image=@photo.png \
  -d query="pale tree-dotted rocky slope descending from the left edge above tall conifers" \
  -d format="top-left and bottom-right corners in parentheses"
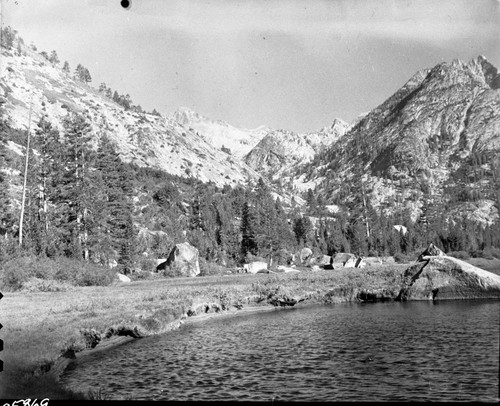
top-left (0, 43), bottom-right (258, 186)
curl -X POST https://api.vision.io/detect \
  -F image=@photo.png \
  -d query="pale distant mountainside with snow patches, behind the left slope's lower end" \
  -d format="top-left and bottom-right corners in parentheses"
top-left (172, 108), bottom-right (271, 159)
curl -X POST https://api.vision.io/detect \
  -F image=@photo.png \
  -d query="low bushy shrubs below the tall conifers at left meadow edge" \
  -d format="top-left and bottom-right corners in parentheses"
top-left (0, 256), bottom-right (115, 292)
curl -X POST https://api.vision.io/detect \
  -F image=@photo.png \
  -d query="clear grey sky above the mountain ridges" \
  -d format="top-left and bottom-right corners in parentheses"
top-left (0, 0), bottom-right (500, 132)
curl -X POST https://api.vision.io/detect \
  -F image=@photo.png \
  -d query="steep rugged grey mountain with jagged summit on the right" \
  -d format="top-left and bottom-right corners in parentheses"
top-left (308, 56), bottom-right (500, 224)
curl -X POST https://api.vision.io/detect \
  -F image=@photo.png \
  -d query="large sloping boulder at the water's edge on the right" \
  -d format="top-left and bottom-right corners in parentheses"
top-left (397, 255), bottom-right (500, 301)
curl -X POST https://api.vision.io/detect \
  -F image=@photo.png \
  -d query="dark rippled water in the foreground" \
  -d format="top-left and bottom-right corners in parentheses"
top-left (64, 301), bottom-right (500, 401)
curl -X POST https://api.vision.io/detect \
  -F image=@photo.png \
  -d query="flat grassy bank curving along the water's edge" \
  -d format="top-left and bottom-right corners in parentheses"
top-left (0, 265), bottom-right (496, 399)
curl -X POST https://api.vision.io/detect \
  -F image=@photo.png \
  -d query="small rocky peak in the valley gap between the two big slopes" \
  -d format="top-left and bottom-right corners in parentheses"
top-left (245, 119), bottom-right (347, 184)
